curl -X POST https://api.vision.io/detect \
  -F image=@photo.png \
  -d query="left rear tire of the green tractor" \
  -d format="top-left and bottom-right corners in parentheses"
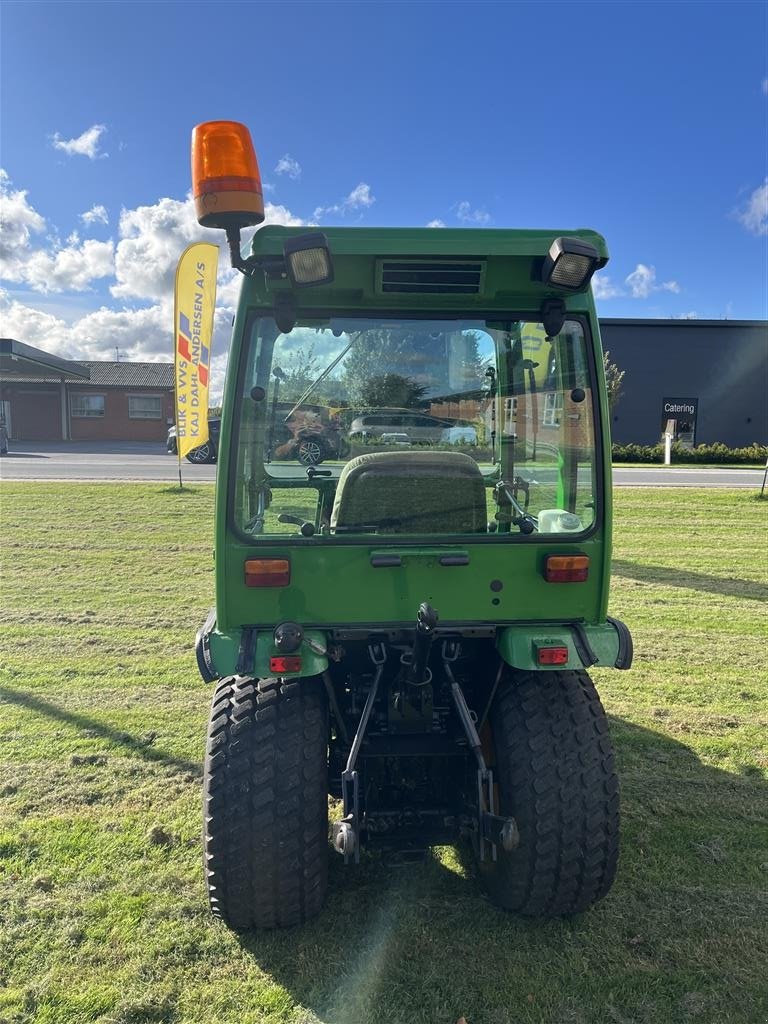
top-left (203, 676), bottom-right (328, 931)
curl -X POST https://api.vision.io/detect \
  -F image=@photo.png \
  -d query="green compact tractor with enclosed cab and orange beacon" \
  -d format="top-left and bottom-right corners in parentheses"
top-left (193, 122), bottom-right (632, 930)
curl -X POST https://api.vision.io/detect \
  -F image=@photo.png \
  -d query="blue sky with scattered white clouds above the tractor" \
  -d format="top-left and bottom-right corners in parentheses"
top-left (0, 0), bottom-right (768, 395)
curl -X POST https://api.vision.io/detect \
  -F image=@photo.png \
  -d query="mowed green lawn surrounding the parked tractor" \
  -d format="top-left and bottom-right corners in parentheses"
top-left (0, 483), bottom-right (768, 1024)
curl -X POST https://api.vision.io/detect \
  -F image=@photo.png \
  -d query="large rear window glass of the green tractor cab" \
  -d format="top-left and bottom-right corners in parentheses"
top-left (231, 311), bottom-right (598, 544)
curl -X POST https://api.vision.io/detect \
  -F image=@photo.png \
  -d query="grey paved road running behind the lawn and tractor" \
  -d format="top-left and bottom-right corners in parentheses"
top-left (0, 441), bottom-right (763, 490)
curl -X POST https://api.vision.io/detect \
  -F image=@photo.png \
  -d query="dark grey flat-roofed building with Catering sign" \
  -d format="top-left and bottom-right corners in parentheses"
top-left (600, 319), bottom-right (768, 447)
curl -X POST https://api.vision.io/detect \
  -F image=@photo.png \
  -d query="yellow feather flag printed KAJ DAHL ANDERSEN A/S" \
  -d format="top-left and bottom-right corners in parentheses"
top-left (173, 242), bottom-right (219, 458)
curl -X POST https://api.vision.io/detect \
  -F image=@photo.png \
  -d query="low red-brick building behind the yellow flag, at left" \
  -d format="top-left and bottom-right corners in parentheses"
top-left (0, 338), bottom-right (174, 441)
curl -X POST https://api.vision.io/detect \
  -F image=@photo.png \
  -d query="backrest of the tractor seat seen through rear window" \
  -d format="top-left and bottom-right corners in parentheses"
top-left (331, 452), bottom-right (487, 534)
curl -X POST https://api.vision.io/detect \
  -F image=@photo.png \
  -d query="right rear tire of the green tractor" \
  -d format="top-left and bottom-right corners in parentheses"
top-left (479, 672), bottom-right (618, 918)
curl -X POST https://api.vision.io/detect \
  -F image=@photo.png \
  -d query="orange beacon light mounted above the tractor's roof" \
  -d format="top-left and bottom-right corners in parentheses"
top-left (191, 121), bottom-right (264, 228)
